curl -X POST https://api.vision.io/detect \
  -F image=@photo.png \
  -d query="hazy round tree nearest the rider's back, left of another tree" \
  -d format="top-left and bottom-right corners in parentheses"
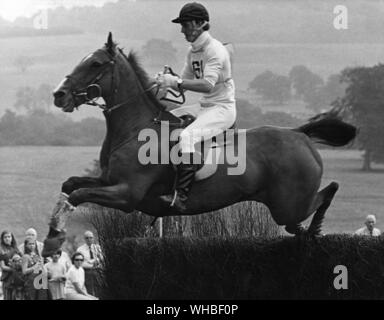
top-left (249, 70), bottom-right (291, 104)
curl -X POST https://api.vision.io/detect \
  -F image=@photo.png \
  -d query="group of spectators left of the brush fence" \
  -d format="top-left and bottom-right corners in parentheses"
top-left (0, 228), bottom-right (103, 300)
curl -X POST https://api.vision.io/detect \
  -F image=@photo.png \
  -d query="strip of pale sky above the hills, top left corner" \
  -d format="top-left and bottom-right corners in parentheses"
top-left (0, 0), bottom-right (117, 21)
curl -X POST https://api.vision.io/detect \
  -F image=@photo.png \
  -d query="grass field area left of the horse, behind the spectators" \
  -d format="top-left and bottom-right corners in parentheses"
top-left (0, 147), bottom-right (99, 244)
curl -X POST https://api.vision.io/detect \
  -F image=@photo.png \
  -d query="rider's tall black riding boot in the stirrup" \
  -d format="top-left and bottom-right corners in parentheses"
top-left (160, 154), bottom-right (198, 213)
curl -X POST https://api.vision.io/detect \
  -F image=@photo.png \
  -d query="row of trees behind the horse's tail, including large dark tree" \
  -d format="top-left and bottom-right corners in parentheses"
top-left (249, 64), bottom-right (384, 171)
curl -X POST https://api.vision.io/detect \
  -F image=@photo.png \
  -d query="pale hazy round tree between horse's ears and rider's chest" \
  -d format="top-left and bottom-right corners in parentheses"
top-left (142, 39), bottom-right (177, 67)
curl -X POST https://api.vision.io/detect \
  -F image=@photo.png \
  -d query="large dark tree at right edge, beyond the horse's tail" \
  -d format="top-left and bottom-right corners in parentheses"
top-left (334, 64), bottom-right (384, 171)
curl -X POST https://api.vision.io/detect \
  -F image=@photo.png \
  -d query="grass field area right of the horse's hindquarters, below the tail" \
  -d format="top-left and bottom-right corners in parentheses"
top-left (321, 150), bottom-right (384, 233)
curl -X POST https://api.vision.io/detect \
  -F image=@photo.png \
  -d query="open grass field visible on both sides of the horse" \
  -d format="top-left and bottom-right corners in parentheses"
top-left (0, 147), bottom-right (384, 244)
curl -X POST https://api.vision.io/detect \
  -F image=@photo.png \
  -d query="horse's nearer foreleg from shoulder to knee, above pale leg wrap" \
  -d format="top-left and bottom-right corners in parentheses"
top-left (68, 183), bottom-right (136, 212)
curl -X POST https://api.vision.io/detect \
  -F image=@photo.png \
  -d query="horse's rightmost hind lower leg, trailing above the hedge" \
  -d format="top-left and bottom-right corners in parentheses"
top-left (307, 182), bottom-right (339, 236)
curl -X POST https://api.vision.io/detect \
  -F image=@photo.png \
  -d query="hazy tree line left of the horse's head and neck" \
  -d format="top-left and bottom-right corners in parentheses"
top-left (0, 83), bottom-right (105, 146)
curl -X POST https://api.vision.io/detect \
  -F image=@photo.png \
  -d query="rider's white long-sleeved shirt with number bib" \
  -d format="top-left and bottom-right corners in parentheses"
top-left (181, 31), bottom-right (235, 107)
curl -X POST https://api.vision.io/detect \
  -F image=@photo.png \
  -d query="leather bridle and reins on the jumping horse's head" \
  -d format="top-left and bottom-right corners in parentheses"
top-left (65, 50), bottom-right (160, 113)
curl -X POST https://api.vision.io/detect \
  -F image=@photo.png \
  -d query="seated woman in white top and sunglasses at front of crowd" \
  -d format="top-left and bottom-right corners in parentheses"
top-left (65, 252), bottom-right (98, 300)
